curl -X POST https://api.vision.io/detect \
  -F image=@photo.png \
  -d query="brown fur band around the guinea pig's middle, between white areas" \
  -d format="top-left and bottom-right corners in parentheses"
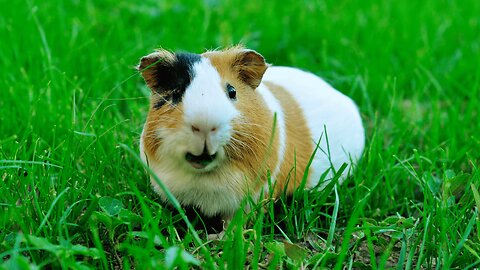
top-left (264, 82), bottom-right (314, 196)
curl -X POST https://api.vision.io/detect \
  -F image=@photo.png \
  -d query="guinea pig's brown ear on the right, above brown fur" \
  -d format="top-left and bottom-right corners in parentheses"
top-left (232, 49), bottom-right (268, 89)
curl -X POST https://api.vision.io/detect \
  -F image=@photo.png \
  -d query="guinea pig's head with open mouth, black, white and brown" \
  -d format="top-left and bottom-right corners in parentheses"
top-left (138, 47), bottom-right (267, 174)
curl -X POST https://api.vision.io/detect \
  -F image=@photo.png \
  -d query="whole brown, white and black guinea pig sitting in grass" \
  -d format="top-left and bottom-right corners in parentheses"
top-left (137, 46), bottom-right (365, 223)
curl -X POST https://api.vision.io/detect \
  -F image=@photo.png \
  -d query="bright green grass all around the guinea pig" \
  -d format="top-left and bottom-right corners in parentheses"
top-left (0, 0), bottom-right (480, 269)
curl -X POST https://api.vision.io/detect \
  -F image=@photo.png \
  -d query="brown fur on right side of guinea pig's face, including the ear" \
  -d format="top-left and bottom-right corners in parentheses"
top-left (203, 47), bottom-right (279, 193)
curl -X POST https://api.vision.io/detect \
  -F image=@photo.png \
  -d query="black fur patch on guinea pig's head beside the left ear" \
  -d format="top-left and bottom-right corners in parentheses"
top-left (154, 53), bottom-right (201, 109)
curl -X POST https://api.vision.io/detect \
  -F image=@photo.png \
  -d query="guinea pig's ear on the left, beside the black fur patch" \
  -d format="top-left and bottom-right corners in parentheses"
top-left (137, 50), bottom-right (175, 92)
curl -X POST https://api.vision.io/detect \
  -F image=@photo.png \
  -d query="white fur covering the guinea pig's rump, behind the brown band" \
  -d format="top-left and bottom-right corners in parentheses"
top-left (263, 67), bottom-right (365, 187)
